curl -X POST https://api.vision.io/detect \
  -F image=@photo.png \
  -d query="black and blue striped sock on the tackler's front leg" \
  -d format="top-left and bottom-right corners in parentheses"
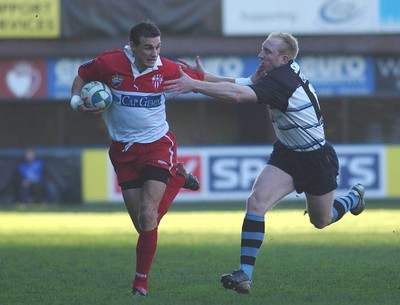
top-left (240, 214), bottom-right (265, 279)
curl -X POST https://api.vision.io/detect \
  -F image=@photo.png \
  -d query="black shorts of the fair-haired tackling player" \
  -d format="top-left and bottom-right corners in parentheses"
top-left (268, 141), bottom-right (339, 196)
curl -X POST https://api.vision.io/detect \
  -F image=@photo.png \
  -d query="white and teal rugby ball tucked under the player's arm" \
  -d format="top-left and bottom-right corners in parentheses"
top-left (81, 81), bottom-right (112, 109)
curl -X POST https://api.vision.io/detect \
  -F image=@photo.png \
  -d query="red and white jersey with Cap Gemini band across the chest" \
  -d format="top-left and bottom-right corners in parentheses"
top-left (78, 47), bottom-right (204, 143)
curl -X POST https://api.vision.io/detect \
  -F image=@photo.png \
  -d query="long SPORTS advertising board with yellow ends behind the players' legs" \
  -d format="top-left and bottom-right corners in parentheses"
top-left (82, 145), bottom-right (390, 202)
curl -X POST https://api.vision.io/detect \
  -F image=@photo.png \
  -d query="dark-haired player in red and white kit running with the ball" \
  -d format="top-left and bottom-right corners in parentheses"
top-left (71, 21), bottom-right (204, 296)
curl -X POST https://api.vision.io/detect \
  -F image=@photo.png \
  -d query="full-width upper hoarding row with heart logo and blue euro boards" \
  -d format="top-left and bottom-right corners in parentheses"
top-left (0, 54), bottom-right (400, 101)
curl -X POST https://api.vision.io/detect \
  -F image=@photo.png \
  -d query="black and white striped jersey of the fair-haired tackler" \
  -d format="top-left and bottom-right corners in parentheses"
top-left (250, 61), bottom-right (325, 152)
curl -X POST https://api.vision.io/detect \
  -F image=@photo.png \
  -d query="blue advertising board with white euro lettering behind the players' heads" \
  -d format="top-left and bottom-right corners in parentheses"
top-left (47, 54), bottom-right (376, 100)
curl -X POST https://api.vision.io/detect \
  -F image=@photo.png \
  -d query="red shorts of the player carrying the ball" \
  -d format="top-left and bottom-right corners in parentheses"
top-left (108, 132), bottom-right (176, 189)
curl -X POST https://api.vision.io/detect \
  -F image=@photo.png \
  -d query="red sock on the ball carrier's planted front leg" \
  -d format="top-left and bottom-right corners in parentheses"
top-left (132, 228), bottom-right (158, 290)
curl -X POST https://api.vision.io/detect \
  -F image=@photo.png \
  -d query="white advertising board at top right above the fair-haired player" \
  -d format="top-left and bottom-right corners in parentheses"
top-left (222, 0), bottom-right (400, 36)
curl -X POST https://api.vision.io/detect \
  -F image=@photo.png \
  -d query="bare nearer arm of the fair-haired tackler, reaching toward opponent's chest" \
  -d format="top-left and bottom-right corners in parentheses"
top-left (164, 67), bottom-right (258, 102)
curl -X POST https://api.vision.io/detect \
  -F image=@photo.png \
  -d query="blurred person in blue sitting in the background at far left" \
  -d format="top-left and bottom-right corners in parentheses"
top-left (18, 148), bottom-right (43, 203)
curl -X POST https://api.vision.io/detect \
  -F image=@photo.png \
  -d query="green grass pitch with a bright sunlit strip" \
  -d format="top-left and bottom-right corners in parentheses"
top-left (0, 202), bottom-right (400, 305)
